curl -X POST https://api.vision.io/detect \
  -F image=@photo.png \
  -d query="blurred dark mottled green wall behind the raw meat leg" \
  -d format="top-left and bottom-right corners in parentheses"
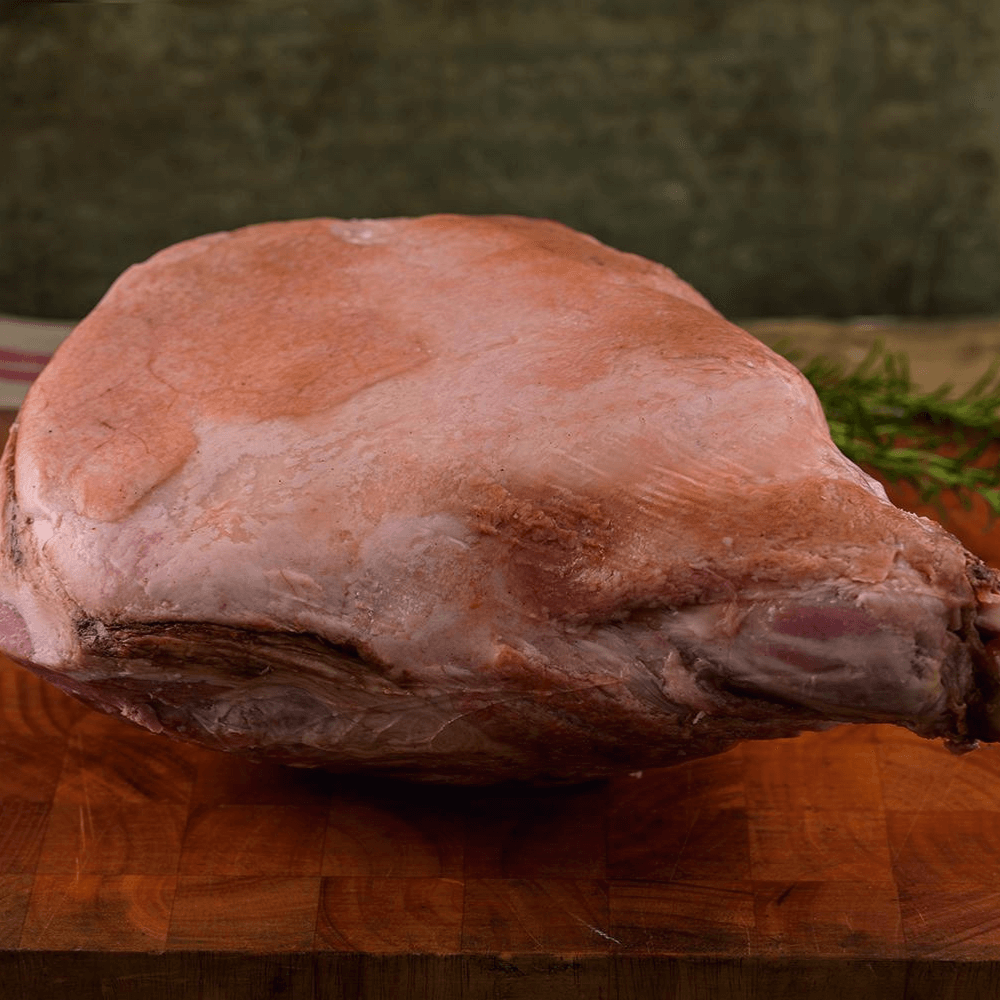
top-left (0, 0), bottom-right (1000, 317)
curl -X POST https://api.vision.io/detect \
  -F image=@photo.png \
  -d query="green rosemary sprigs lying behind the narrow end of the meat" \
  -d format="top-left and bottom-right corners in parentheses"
top-left (778, 342), bottom-right (1000, 516)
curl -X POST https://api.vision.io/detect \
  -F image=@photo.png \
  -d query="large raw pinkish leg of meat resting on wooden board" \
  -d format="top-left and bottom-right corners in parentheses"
top-left (0, 215), bottom-right (1000, 783)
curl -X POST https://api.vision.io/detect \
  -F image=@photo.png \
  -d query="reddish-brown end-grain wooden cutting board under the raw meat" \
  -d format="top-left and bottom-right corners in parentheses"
top-left (0, 376), bottom-right (1000, 1000)
